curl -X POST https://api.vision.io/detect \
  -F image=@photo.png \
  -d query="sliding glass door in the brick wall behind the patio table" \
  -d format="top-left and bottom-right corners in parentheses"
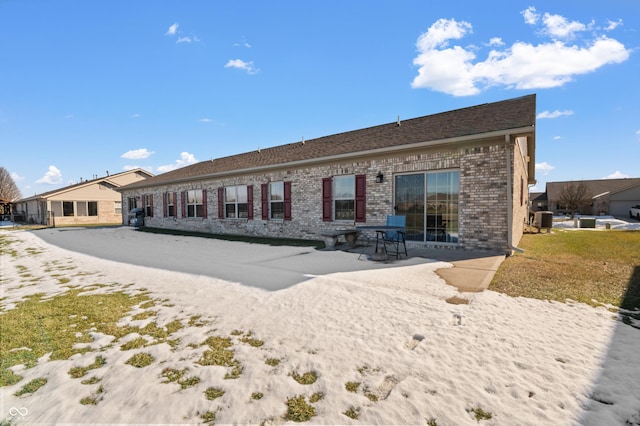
top-left (394, 171), bottom-right (460, 243)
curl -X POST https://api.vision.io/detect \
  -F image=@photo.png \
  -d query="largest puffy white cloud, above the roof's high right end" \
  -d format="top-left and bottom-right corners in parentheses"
top-left (411, 8), bottom-right (630, 96)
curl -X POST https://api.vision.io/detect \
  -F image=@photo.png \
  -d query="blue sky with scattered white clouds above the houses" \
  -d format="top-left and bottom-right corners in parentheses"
top-left (0, 0), bottom-right (640, 197)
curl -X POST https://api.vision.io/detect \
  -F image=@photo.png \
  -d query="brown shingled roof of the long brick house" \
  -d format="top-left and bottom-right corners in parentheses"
top-left (121, 94), bottom-right (536, 189)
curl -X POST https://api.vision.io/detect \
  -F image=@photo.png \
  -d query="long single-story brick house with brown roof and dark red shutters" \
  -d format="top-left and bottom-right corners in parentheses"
top-left (118, 94), bottom-right (536, 253)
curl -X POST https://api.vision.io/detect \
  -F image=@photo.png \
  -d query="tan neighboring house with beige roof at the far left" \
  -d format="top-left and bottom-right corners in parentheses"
top-left (13, 169), bottom-right (153, 226)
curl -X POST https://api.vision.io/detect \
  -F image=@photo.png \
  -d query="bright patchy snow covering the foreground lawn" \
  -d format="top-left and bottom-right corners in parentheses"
top-left (0, 231), bottom-right (640, 425)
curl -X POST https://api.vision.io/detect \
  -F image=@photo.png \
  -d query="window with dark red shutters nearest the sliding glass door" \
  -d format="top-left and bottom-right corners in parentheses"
top-left (322, 175), bottom-right (366, 222)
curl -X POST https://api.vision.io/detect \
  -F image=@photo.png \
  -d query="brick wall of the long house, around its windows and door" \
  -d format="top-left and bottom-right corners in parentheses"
top-left (122, 138), bottom-right (519, 251)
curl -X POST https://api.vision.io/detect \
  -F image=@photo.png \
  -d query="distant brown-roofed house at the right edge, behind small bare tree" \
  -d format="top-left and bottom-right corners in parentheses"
top-left (546, 178), bottom-right (640, 217)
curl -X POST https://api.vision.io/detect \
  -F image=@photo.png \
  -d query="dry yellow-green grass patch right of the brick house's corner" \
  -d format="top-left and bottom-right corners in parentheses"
top-left (489, 230), bottom-right (640, 310)
